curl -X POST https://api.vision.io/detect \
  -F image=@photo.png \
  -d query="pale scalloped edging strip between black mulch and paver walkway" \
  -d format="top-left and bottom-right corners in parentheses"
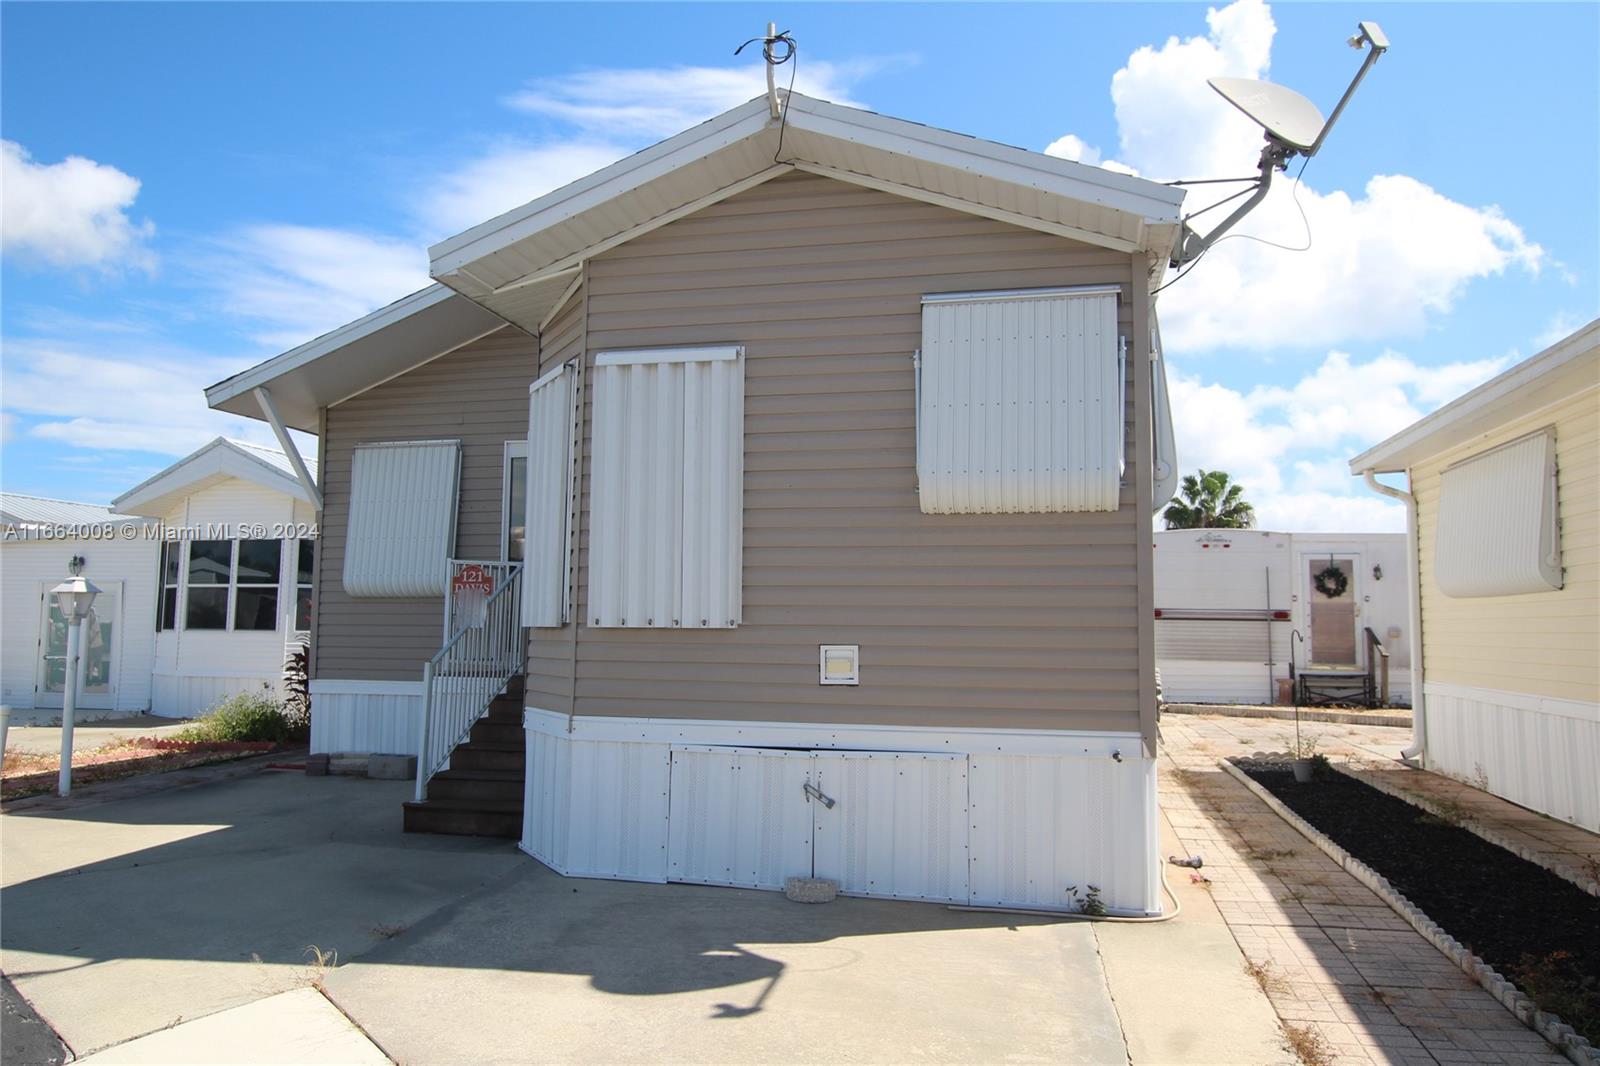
top-left (1218, 759), bottom-right (1600, 1066)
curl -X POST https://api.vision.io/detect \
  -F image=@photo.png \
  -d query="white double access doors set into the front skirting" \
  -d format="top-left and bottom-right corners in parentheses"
top-left (667, 746), bottom-right (968, 903)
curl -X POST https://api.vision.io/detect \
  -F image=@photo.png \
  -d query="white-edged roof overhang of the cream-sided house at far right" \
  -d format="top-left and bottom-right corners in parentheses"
top-left (1350, 319), bottom-right (1600, 474)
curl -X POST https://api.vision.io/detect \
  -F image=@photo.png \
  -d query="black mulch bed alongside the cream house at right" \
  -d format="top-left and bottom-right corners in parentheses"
top-left (1237, 760), bottom-right (1600, 1045)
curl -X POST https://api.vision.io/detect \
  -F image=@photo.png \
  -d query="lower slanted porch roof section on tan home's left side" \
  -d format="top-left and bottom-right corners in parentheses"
top-left (205, 285), bottom-right (506, 434)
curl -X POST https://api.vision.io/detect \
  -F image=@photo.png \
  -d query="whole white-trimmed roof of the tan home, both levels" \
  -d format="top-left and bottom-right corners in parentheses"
top-left (206, 93), bottom-right (1184, 432)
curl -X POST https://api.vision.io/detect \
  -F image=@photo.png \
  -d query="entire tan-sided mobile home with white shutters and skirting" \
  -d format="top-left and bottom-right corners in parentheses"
top-left (206, 94), bottom-right (1182, 914)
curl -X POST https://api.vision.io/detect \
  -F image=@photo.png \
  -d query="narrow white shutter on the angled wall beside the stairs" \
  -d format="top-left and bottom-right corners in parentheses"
top-left (522, 365), bottom-right (576, 626)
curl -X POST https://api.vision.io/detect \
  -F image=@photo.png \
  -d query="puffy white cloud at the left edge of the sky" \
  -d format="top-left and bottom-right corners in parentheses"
top-left (0, 141), bottom-right (155, 271)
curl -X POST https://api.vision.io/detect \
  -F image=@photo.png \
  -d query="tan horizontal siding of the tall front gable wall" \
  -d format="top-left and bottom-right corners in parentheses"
top-left (550, 174), bottom-right (1154, 730)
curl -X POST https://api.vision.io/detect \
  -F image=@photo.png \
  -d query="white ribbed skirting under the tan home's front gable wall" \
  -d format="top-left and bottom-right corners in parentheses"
top-left (522, 707), bottom-right (1162, 914)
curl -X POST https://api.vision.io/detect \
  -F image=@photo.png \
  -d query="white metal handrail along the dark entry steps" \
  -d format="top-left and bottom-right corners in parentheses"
top-left (416, 563), bottom-right (528, 802)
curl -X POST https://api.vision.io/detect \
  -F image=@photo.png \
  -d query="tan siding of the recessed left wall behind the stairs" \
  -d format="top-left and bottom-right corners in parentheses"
top-left (315, 327), bottom-right (539, 680)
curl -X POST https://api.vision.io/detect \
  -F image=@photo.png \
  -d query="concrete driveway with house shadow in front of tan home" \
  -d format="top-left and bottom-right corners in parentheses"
top-left (0, 773), bottom-right (1285, 1063)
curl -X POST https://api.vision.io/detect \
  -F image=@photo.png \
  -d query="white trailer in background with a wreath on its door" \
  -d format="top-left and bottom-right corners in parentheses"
top-left (1155, 530), bottom-right (1411, 704)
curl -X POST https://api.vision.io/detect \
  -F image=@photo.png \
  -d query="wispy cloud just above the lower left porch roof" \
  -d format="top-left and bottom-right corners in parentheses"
top-left (198, 224), bottom-right (429, 349)
